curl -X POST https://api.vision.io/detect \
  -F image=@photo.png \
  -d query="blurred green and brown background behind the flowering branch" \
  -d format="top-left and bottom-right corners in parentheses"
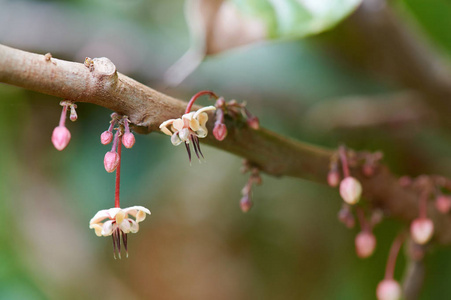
top-left (0, 0), bottom-right (451, 299)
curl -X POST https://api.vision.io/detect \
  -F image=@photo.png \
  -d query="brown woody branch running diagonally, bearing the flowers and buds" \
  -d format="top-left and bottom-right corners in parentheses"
top-left (0, 45), bottom-right (451, 244)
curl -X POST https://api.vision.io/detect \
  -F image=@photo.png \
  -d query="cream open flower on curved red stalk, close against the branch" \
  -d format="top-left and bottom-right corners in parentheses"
top-left (160, 106), bottom-right (216, 161)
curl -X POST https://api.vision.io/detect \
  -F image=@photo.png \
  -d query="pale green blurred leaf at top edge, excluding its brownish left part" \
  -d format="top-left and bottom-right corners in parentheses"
top-left (229, 0), bottom-right (362, 38)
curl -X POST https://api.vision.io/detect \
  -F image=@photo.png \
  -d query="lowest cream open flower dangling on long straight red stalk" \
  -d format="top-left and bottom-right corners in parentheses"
top-left (89, 206), bottom-right (150, 258)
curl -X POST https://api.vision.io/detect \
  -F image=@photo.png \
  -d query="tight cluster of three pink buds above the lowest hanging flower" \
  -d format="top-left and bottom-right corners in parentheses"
top-left (100, 113), bottom-right (135, 173)
